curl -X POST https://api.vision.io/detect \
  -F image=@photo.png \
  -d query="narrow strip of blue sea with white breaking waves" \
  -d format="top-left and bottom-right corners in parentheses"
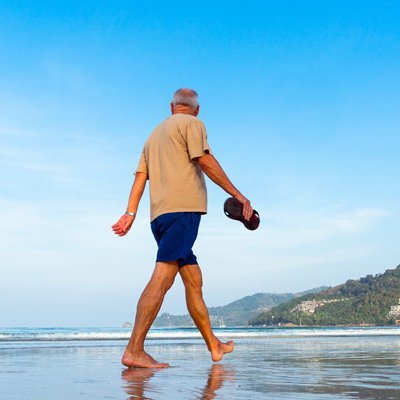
top-left (0, 327), bottom-right (400, 342)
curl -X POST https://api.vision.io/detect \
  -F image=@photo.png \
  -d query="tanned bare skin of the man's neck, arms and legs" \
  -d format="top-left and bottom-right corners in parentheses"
top-left (112, 103), bottom-right (253, 368)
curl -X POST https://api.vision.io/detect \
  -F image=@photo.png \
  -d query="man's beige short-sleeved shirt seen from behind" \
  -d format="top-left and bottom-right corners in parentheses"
top-left (136, 114), bottom-right (211, 221)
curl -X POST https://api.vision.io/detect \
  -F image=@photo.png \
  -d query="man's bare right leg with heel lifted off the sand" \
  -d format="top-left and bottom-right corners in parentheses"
top-left (179, 264), bottom-right (233, 361)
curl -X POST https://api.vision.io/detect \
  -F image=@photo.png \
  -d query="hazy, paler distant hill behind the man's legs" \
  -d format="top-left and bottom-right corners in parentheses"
top-left (154, 286), bottom-right (327, 327)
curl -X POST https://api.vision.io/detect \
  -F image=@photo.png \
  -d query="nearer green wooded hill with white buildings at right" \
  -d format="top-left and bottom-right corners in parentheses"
top-left (249, 265), bottom-right (400, 325)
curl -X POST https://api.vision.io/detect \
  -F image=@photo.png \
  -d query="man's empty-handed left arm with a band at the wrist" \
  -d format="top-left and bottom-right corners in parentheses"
top-left (112, 172), bottom-right (147, 236)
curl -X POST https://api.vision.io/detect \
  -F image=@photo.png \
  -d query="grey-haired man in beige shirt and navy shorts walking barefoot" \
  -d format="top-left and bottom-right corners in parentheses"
top-left (112, 89), bottom-right (253, 368)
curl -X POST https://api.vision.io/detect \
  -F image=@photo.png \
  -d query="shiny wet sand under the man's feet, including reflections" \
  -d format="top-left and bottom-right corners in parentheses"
top-left (0, 336), bottom-right (400, 400)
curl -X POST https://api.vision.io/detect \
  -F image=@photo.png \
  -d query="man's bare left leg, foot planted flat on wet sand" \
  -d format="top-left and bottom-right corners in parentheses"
top-left (122, 262), bottom-right (178, 368)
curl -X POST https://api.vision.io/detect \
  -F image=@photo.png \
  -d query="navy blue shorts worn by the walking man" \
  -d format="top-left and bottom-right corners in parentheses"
top-left (151, 212), bottom-right (201, 267)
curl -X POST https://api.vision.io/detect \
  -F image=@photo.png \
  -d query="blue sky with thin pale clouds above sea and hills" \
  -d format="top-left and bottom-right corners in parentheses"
top-left (0, 0), bottom-right (400, 326)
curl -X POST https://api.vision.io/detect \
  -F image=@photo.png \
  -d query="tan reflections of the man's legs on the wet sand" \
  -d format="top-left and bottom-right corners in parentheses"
top-left (122, 364), bottom-right (235, 400)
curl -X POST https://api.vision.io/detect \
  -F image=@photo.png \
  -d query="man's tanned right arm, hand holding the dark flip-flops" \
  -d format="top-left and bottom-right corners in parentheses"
top-left (195, 154), bottom-right (253, 220)
